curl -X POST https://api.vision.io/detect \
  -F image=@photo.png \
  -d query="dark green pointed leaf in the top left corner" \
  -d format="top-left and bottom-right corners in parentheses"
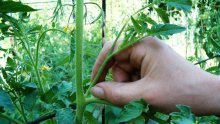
top-left (0, 1), bottom-right (36, 13)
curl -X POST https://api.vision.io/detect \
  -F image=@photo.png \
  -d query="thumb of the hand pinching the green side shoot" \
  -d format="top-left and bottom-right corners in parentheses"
top-left (92, 81), bottom-right (143, 105)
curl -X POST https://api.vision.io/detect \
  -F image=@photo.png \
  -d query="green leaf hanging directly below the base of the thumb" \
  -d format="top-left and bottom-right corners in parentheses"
top-left (116, 101), bottom-right (145, 122)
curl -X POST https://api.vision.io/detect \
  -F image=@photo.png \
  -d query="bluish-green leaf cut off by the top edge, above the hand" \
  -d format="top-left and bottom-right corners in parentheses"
top-left (166, 0), bottom-right (192, 12)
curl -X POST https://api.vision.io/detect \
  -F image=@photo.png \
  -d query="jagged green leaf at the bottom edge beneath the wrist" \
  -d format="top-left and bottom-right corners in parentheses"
top-left (170, 105), bottom-right (195, 124)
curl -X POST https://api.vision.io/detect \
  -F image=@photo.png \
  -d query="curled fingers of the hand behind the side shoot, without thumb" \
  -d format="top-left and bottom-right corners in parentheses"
top-left (92, 37), bottom-right (161, 82)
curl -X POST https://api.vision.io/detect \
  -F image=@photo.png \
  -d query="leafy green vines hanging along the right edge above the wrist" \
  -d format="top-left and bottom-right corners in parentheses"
top-left (192, 0), bottom-right (220, 71)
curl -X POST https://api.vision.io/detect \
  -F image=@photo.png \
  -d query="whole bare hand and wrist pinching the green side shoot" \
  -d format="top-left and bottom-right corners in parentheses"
top-left (92, 37), bottom-right (220, 115)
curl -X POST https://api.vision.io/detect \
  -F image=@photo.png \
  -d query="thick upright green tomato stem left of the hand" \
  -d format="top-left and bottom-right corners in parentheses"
top-left (75, 0), bottom-right (85, 124)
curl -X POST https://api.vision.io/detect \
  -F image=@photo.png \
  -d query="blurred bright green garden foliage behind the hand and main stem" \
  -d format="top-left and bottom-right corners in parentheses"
top-left (0, 0), bottom-right (220, 124)
